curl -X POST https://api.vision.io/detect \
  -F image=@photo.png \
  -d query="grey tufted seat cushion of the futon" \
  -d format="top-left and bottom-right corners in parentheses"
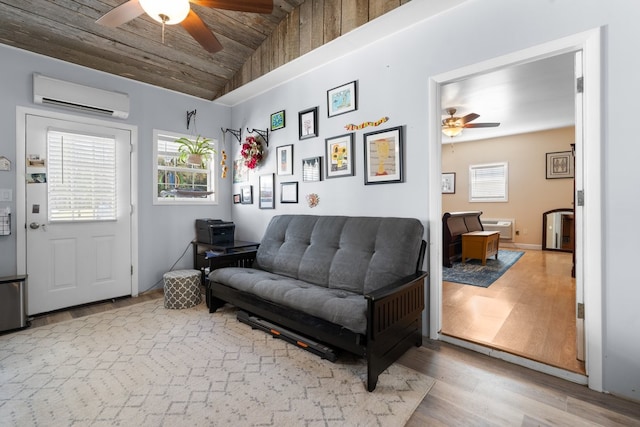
top-left (209, 267), bottom-right (367, 334)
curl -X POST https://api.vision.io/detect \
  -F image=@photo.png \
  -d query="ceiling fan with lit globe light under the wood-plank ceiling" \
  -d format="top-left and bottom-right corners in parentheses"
top-left (96, 0), bottom-right (273, 53)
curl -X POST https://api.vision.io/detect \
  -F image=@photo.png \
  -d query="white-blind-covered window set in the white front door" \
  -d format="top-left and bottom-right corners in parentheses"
top-left (47, 129), bottom-right (117, 222)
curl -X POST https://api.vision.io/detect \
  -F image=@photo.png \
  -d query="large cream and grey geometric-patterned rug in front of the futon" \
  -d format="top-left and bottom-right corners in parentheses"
top-left (0, 299), bottom-right (434, 426)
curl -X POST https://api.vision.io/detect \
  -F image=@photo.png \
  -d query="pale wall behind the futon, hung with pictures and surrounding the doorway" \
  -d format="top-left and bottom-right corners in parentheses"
top-left (232, 0), bottom-right (640, 400)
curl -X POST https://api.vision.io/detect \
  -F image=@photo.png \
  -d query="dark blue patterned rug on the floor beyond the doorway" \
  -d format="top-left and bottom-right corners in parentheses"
top-left (442, 250), bottom-right (524, 288)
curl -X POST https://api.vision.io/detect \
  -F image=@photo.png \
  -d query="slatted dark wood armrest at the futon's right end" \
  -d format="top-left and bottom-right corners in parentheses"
top-left (364, 271), bottom-right (427, 340)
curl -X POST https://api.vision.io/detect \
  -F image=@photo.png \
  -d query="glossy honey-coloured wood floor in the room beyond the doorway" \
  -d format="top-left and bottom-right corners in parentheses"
top-left (442, 250), bottom-right (585, 374)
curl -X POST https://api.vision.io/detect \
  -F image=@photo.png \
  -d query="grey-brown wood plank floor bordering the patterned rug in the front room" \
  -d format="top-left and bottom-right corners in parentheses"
top-left (25, 289), bottom-right (640, 427)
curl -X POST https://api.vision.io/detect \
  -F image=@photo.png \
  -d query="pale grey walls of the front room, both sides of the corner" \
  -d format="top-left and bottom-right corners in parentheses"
top-left (0, 0), bottom-right (640, 400)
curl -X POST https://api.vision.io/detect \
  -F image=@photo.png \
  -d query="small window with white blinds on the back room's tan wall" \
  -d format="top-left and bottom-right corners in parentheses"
top-left (469, 162), bottom-right (509, 202)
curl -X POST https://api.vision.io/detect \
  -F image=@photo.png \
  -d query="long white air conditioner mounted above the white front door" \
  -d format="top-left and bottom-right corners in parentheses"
top-left (33, 73), bottom-right (129, 119)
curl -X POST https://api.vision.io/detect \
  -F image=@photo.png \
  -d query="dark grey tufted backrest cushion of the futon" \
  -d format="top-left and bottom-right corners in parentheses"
top-left (255, 215), bottom-right (424, 293)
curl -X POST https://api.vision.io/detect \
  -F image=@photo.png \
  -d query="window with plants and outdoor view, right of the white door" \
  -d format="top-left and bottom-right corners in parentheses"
top-left (153, 130), bottom-right (216, 205)
